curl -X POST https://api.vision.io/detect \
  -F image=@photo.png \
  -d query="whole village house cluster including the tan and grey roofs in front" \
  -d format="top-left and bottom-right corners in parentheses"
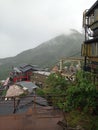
top-left (0, 58), bottom-right (82, 108)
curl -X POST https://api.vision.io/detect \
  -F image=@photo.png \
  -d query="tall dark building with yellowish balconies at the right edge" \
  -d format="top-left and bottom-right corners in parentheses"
top-left (82, 1), bottom-right (98, 80)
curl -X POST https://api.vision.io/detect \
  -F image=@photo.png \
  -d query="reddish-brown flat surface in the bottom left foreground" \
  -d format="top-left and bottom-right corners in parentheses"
top-left (0, 106), bottom-right (62, 130)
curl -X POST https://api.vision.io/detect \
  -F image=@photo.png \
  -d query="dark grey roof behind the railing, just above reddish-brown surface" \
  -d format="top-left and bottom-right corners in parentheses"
top-left (0, 95), bottom-right (48, 115)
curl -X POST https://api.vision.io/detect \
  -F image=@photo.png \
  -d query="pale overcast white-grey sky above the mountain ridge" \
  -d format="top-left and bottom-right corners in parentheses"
top-left (0, 0), bottom-right (96, 58)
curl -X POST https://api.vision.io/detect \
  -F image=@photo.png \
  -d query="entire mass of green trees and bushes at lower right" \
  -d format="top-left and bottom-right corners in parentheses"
top-left (36, 71), bottom-right (98, 130)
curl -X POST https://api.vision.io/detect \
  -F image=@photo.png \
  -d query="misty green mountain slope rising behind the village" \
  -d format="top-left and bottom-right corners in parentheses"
top-left (0, 30), bottom-right (84, 79)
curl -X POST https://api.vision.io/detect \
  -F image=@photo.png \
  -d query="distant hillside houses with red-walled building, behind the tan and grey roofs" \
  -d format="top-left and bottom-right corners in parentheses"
top-left (1, 57), bottom-right (82, 87)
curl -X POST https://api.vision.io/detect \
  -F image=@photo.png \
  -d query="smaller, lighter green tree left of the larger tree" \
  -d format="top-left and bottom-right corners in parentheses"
top-left (46, 73), bottom-right (67, 107)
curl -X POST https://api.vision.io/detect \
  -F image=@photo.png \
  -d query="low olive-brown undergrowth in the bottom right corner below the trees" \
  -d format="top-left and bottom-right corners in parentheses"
top-left (65, 111), bottom-right (98, 130)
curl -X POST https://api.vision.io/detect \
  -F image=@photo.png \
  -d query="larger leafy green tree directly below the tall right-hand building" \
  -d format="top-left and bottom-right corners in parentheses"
top-left (65, 71), bottom-right (98, 113)
